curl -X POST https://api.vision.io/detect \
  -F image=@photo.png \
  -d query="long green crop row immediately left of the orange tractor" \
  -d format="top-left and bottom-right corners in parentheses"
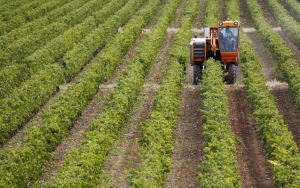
top-left (128, 0), bottom-right (199, 187)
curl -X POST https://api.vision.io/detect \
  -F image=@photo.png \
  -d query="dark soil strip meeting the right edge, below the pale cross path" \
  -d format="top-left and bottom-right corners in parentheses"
top-left (269, 85), bottom-right (300, 149)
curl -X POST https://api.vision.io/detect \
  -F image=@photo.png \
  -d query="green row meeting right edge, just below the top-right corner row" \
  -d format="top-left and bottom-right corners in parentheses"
top-left (265, 0), bottom-right (300, 48)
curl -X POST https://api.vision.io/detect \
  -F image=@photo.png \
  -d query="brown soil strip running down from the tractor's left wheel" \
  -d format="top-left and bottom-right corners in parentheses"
top-left (166, 82), bottom-right (204, 188)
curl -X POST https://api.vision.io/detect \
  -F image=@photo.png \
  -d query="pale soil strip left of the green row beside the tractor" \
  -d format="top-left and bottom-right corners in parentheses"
top-left (104, 32), bottom-right (175, 187)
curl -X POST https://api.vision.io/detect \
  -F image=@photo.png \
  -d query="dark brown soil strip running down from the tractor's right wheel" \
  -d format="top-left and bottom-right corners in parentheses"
top-left (226, 86), bottom-right (274, 188)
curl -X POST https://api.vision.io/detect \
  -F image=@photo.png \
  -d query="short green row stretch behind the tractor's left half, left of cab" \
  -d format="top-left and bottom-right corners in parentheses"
top-left (204, 0), bottom-right (219, 27)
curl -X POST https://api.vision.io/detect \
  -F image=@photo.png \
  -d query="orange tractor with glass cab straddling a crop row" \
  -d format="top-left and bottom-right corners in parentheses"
top-left (190, 18), bottom-right (240, 84)
